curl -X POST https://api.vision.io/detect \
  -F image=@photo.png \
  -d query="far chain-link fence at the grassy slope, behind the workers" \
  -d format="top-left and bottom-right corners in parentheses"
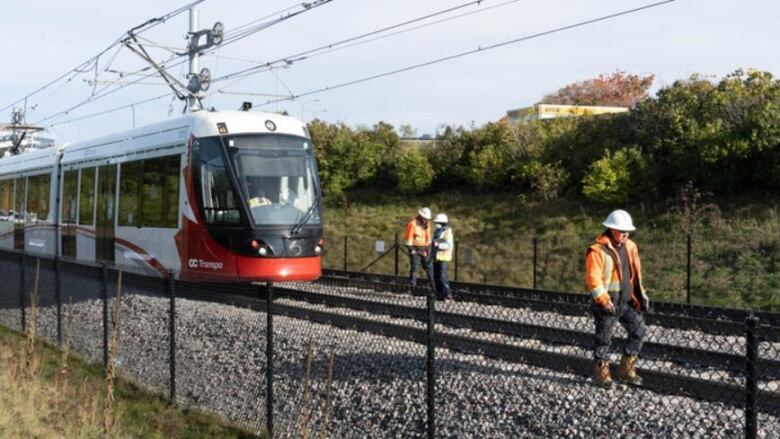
top-left (323, 229), bottom-right (780, 312)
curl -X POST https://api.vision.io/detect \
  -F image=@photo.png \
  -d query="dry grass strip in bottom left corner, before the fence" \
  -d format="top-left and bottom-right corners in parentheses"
top-left (0, 327), bottom-right (252, 438)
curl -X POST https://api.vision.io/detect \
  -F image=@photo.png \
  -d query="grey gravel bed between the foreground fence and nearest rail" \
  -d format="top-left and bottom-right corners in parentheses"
top-left (0, 292), bottom-right (780, 438)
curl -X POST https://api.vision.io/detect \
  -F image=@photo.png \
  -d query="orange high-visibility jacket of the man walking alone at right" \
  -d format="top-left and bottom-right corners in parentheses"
top-left (585, 234), bottom-right (645, 310)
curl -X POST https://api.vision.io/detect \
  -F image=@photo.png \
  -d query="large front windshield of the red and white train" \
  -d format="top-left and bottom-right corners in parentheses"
top-left (225, 134), bottom-right (321, 226)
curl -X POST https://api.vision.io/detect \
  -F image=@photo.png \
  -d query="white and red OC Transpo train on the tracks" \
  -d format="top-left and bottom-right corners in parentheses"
top-left (0, 111), bottom-right (323, 281)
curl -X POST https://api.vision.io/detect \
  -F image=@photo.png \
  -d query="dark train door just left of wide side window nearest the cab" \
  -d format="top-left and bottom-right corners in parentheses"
top-left (95, 165), bottom-right (117, 262)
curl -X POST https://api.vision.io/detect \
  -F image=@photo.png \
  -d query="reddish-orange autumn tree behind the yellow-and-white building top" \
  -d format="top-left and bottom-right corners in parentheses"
top-left (541, 70), bottom-right (655, 108)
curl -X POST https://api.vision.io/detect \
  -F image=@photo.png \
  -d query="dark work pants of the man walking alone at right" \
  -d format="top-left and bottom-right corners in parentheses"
top-left (593, 304), bottom-right (647, 361)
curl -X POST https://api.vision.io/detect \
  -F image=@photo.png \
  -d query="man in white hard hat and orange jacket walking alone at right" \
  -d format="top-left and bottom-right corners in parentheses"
top-left (585, 210), bottom-right (650, 387)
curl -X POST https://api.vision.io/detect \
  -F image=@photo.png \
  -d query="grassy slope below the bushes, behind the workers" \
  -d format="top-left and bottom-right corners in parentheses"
top-left (324, 190), bottom-right (780, 311)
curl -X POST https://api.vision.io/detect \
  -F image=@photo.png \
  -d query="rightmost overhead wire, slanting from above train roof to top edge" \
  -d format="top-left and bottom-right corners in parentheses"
top-left (258, 0), bottom-right (676, 106)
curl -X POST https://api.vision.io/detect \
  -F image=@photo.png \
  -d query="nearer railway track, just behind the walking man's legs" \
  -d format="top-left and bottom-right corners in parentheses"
top-left (117, 276), bottom-right (780, 415)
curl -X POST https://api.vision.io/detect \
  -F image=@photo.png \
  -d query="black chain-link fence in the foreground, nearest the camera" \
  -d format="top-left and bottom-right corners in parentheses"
top-left (0, 249), bottom-right (780, 438)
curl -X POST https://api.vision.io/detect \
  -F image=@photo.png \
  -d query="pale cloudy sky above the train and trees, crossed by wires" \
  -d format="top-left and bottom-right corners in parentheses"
top-left (0, 0), bottom-right (780, 143)
